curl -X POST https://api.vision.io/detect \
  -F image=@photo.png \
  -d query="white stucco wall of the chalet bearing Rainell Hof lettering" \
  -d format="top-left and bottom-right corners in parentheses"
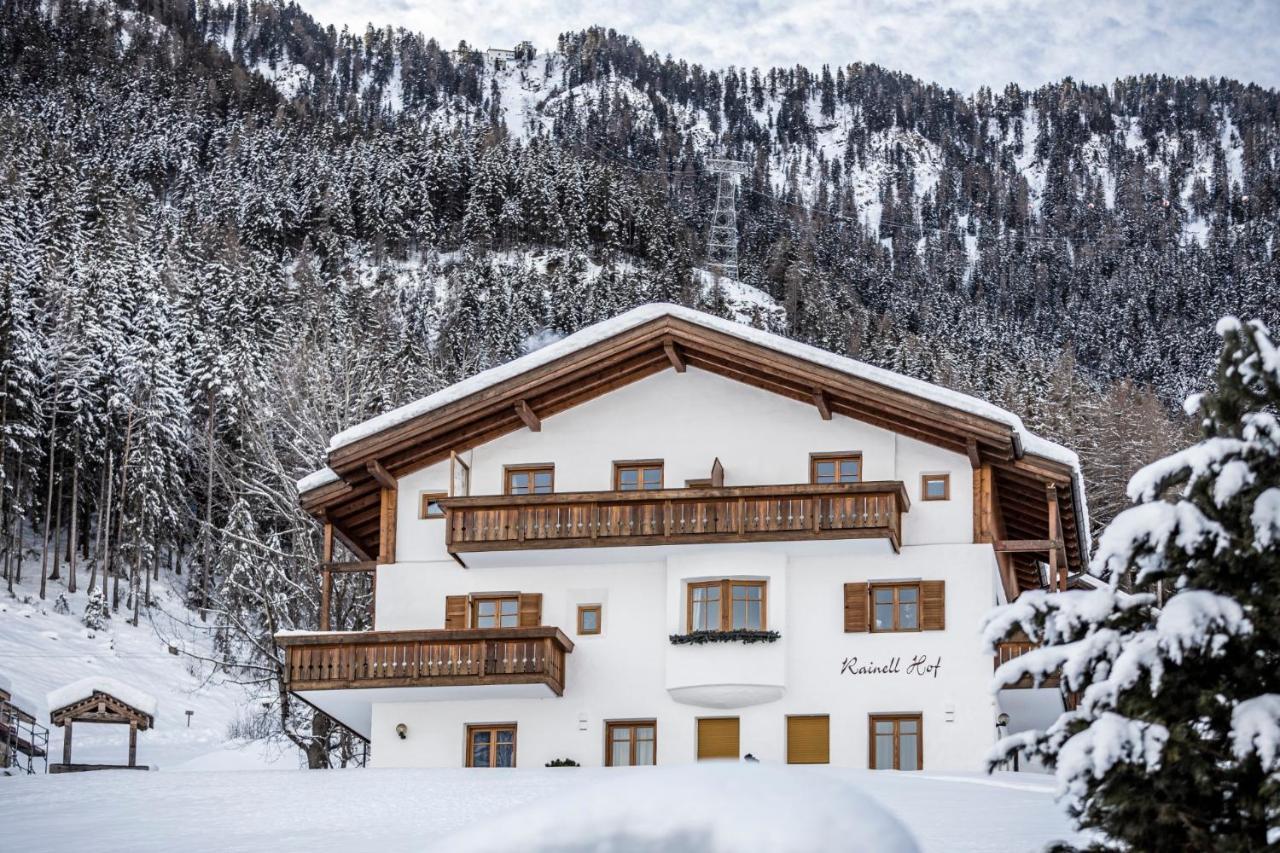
top-left (309, 368), bottom-right (1029, 770)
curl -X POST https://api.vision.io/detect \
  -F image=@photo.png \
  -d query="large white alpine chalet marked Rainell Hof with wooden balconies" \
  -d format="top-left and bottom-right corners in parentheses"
top-left (278, 305), bottom-right (1088, 770)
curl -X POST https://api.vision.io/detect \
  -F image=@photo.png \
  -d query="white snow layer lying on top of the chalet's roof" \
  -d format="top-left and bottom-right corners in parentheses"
top-left (320, 302), bottom-right (1080, 466)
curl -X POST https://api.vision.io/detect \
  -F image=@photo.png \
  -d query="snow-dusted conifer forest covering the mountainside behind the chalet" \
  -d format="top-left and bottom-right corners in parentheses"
top-left (0, 0), bottom-right (1280, 763)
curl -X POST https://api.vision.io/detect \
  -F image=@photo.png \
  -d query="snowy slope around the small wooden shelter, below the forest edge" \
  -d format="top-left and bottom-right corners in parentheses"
top-left (0, 556), bottom-right (279, 768)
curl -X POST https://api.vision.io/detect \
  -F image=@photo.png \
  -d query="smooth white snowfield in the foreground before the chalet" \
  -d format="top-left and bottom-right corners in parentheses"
top-left (0, 763), bottom-right (1071, 853)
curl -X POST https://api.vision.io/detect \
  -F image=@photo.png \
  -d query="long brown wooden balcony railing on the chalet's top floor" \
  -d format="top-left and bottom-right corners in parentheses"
top-left (440, 480), bottom-right (910, 553)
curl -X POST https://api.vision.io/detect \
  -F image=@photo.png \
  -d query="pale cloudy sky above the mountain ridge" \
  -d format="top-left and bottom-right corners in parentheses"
top-left (301, 0), bottom-right (1280, 91)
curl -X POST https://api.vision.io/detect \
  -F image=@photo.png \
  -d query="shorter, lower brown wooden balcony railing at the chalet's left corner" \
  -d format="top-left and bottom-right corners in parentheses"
top-left (275, 626), bottom-right (573, 695)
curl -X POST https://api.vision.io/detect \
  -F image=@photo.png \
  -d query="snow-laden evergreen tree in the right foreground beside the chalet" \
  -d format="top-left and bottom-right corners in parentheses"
top-left (986, 318), bottom-right (1280, 850)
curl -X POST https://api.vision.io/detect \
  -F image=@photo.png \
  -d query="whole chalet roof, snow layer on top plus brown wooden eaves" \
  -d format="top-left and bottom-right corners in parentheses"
top-left (298, 304), bottom-right (1088, 588)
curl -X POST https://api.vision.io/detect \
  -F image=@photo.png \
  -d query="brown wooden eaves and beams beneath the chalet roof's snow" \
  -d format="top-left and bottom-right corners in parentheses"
top-left (301, 314), bottom-right (1087, 588)
